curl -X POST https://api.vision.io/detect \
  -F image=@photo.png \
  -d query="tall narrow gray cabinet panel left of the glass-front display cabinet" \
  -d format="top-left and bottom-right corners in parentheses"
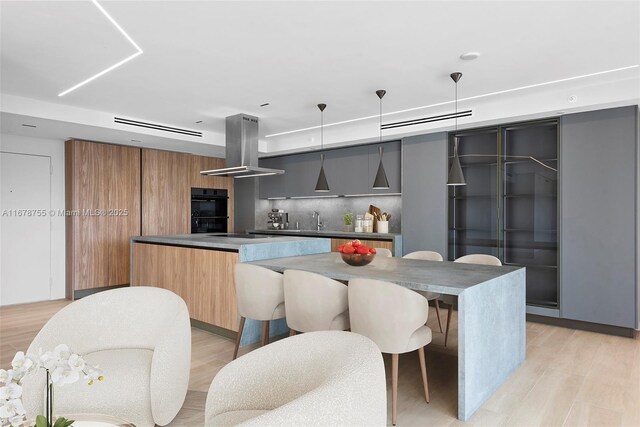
top-left (402, 132), bottom-right (448, 257)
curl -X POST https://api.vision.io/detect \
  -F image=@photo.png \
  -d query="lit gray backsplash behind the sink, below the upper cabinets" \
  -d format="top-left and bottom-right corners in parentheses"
top-left (256, 196), bottom-right (402, 233)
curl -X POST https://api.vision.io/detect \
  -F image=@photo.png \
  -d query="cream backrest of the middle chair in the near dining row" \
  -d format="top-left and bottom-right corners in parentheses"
top-left (284, 270), bottom-right (349, 332)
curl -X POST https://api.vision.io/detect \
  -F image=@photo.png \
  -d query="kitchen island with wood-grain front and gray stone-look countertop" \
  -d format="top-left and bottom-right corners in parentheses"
top-left (130, 233), bottom-right (331, 345)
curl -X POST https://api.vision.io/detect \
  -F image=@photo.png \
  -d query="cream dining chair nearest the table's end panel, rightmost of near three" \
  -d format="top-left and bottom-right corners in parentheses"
top-left (349, 279), bottom-right (431, 425)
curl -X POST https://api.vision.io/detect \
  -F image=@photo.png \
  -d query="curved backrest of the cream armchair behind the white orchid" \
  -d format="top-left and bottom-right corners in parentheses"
top-left (29, 286), bottom-right (189, 354)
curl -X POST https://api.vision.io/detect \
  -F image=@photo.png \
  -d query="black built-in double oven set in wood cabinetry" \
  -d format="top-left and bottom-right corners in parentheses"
top-left (191, 188), bottom-right (229, 233)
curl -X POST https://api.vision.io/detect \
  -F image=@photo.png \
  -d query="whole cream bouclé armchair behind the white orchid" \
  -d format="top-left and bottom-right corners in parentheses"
top-left (23, 286), bottom-right (191, 427)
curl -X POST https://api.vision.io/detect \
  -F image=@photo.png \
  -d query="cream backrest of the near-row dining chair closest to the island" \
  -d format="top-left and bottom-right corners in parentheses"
top-left (234, 263), bottom-right (284, 320)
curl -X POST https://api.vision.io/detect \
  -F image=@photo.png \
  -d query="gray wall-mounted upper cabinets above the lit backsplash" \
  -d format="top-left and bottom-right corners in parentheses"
top-left (259, 141), bottom-right (401, 199)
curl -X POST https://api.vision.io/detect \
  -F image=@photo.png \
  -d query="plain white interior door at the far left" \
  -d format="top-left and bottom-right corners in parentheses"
top-left (0, 153), bottom-right (51, 305)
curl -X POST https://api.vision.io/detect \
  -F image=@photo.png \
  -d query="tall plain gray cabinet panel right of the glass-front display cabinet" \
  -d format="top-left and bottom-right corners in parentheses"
top-left (560, 106), bottom-right (638, 328)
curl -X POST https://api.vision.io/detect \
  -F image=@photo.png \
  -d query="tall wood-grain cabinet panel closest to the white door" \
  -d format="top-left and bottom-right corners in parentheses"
top-left (65, 140), bottom-right (140, 299)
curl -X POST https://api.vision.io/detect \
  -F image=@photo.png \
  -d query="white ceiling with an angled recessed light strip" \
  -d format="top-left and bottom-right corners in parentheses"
top-left (0, 0), bottom-right (640, 154)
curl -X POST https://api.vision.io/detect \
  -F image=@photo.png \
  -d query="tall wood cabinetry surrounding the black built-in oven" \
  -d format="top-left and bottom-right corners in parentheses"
top-left (142, 148), bottom-right (234, 236)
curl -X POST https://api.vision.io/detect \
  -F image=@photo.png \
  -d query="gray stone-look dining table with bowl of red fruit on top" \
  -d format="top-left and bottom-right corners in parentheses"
top-left (251, 252), bottom-right (526, 421)
